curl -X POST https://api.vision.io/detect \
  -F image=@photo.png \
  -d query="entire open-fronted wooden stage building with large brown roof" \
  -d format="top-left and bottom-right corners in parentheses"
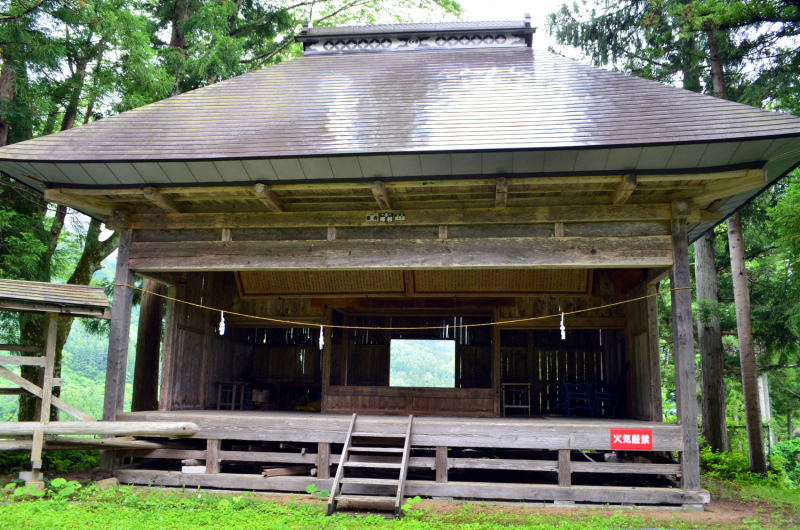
top-left (0, 18), bottom-right (800, 507)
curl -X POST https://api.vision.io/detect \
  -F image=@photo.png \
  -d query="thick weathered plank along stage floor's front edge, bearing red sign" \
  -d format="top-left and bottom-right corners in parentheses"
top-left (117, 410), bottom-right (683, 451)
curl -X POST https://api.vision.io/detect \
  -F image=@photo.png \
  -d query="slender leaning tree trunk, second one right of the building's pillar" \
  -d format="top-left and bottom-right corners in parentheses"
top-left (728, 213), bottom-right (767, 475)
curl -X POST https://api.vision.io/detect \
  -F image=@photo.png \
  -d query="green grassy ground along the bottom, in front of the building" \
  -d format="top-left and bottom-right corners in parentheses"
top-left (0, 474), bottom-right (800, 530)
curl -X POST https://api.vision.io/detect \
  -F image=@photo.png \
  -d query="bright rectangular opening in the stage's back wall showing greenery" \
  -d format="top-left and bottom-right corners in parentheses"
top-left (389, 339), bottom-right (456, 388)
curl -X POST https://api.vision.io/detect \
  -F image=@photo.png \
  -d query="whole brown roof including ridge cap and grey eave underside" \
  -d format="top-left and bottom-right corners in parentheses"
top-left (0, 22), bottom-right (800, 239)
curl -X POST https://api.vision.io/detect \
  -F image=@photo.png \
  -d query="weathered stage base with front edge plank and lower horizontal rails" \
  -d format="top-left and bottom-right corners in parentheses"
top-left (115, 410), bottom-right (710, 506)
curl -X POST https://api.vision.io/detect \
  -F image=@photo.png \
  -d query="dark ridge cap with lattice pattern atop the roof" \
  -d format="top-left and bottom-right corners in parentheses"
top-left (297, 17), bottom-right (536, 55)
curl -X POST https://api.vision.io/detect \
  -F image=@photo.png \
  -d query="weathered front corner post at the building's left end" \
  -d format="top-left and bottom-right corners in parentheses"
top-left (100, 229), bottom-right (133, 473)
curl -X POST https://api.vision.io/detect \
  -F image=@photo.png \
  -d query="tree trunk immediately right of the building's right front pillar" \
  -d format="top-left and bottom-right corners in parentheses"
top-left (694, 230), bottom-right (728, 451)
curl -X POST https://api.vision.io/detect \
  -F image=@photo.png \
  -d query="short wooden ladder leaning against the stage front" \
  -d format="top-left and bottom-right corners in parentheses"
top-left (328, 414), bottom-right (414, 517)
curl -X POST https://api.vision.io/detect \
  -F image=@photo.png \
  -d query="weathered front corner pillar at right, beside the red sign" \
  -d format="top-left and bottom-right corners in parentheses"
top-left (670, 219), bottom-right (700, 491)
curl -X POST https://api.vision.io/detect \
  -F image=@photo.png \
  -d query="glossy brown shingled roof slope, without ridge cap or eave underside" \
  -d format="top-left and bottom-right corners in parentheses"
top-left (0, 47), bottom-right (800, 163)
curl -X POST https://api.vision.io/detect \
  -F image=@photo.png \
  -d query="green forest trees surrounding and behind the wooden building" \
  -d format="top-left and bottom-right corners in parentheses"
top-left (0, 0), bottom-right (800, 474)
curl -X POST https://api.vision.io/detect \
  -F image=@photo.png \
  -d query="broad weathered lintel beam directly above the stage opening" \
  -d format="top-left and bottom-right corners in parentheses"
top-left (130, 236), bottom-right (672, 270)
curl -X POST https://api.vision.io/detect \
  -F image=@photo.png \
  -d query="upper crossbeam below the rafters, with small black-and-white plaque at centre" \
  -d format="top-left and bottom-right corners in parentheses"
top-left (131, 204), bottom-right (680, 230)
